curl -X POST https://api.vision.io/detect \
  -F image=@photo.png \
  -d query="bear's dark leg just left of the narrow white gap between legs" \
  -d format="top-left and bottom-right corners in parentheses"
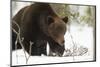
top-left (31, 40), bottom-right (47, 56)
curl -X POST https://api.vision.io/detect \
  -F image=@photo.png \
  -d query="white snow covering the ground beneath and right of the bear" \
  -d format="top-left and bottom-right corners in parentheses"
top-left (12, 25), bottom-right (94, 65)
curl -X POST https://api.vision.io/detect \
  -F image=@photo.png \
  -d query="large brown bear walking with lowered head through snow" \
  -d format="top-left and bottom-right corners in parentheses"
top-left (12, 3), bottom-right (68, 56)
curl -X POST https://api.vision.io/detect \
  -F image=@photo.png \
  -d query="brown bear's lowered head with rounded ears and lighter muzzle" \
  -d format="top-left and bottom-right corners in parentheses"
top-left (48, 16), bottom-right (68, 46)
